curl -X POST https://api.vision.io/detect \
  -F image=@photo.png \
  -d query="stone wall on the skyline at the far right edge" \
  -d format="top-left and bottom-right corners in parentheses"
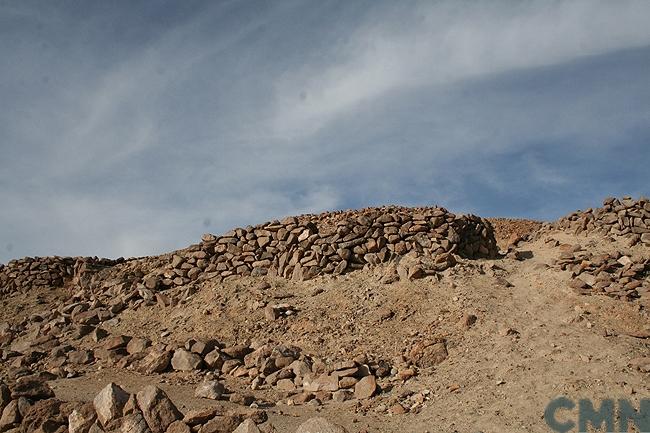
top-left (557, 197), bottom-right (650, 245)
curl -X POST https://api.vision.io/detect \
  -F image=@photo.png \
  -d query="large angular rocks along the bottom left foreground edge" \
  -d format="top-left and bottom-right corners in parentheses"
top-left (0, 376), bottom-right (346, 433)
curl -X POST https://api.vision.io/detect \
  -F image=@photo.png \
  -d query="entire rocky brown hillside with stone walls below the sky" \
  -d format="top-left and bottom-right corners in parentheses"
top-left (0, 197), bottom-right (650, 433)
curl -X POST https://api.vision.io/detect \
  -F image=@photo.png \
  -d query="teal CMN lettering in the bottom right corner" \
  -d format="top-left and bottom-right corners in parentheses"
top-left (544, 397), bottom-right (650, 433)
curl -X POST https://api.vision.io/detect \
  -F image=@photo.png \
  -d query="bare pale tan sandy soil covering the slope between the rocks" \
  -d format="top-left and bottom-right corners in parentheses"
top-left (2, 225), bottom-right (650, 433)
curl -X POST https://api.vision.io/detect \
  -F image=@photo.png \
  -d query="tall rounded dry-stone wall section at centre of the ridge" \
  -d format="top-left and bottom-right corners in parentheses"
top-left (160, 207), bottom-right (497, 286)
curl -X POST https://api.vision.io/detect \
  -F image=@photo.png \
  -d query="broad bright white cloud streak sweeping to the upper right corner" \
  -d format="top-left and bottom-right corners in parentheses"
top-left (274, 0), bottom-right (650, 139)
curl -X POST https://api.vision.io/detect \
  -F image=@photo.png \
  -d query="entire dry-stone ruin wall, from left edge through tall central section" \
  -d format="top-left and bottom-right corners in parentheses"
top-left (0, 206), bottom-right (498, 294)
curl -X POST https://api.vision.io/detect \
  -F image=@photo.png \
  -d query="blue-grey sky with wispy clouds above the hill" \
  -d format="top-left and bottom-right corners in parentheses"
top-left (0, 0), bottom-right (650, 263)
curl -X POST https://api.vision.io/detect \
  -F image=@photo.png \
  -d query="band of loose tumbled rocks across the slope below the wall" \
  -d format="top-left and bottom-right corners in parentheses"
top-left (0, 296), bottom-right (440, 410)
